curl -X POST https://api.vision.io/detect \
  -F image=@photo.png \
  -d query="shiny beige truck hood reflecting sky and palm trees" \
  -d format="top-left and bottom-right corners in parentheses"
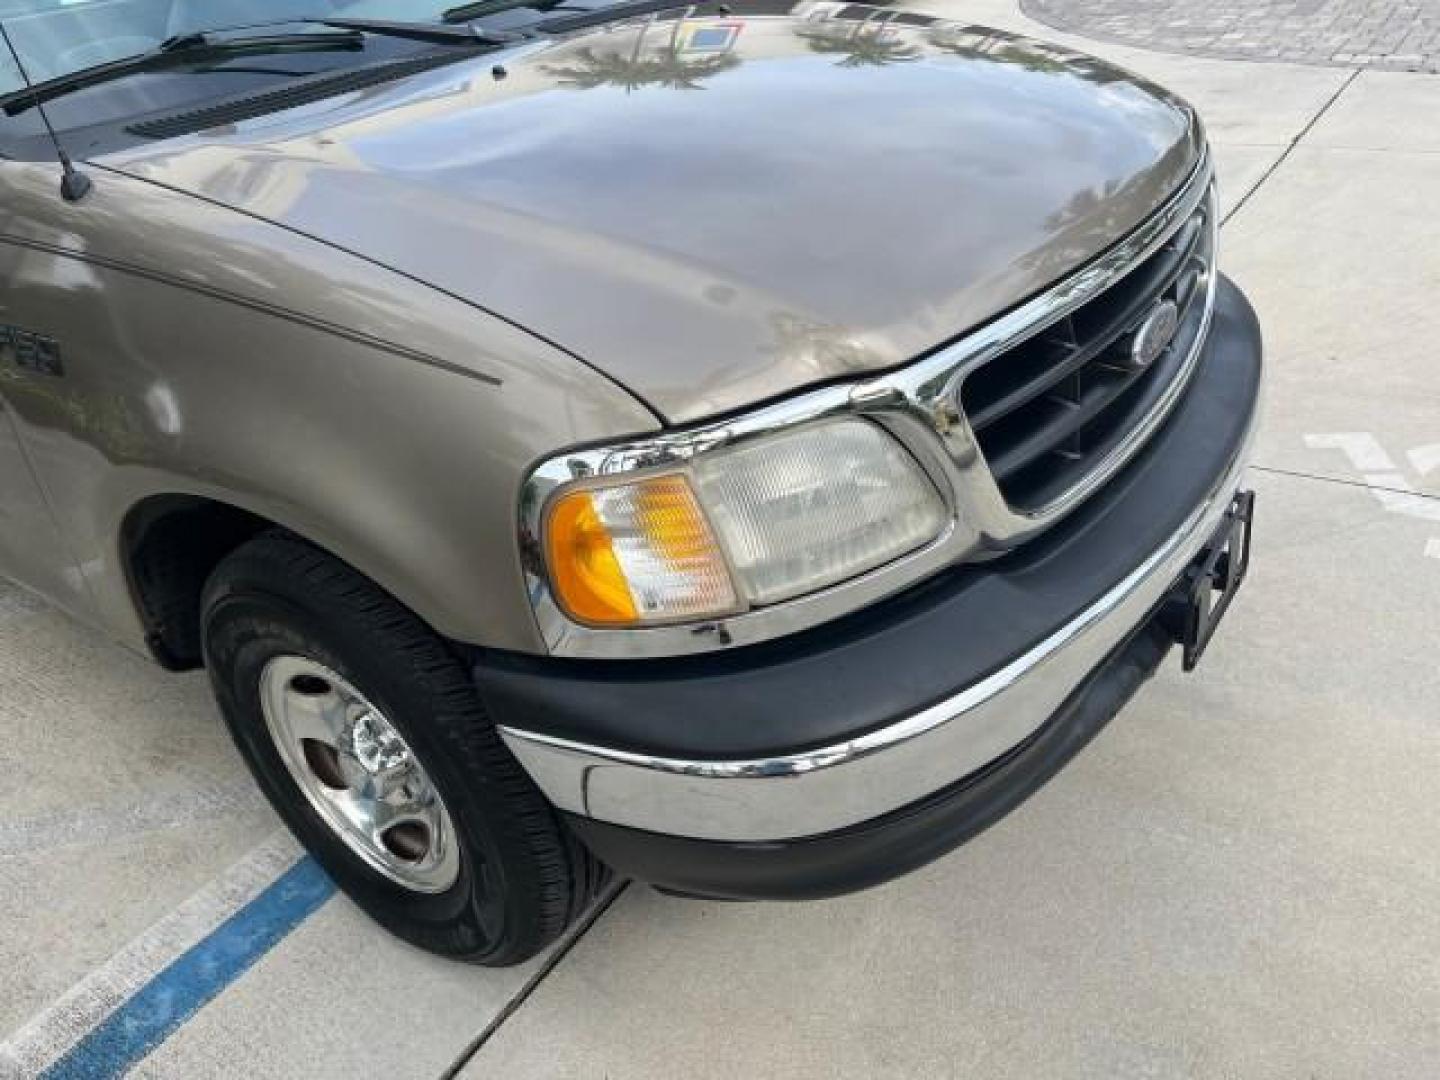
top-left (105, 13), bottom-right (1202, 422)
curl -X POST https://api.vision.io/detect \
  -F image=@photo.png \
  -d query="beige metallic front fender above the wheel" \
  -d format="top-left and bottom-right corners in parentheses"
top-left (0, 166), bottom-right (657, 651)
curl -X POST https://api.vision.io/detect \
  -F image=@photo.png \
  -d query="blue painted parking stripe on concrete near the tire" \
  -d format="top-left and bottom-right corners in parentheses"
top-left (42, 858), bottom-right (336, 1080)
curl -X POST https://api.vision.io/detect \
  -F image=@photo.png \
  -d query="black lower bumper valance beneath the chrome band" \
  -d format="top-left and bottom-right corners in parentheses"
top-left (564, 619), bottom-right (1171, 900)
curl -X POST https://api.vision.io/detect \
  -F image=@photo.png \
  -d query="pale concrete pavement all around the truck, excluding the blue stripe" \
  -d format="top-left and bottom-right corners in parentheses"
top-left (0, 0), bottom-right (1440, 1080)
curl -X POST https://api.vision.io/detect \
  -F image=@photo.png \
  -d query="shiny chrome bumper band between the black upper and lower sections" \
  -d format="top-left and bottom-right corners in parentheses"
top-left (500, 422), bottom-right (1254, 841)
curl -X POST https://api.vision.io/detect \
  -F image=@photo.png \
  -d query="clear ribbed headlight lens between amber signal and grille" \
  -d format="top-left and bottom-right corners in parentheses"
top-left (696, 420), bottom-right (948, 603)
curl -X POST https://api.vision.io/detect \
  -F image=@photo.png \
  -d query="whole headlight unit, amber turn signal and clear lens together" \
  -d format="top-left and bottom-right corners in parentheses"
top-left (544, 419), bottom-right (949, 626)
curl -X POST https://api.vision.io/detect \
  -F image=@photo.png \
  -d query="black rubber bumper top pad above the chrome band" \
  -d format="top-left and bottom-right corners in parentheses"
top-left (474, 281), bottom-right (1261, 760)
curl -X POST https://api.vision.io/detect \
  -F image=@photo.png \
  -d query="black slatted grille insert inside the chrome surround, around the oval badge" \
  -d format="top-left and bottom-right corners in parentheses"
top-left (960, 190), bottom-right (1215, 513)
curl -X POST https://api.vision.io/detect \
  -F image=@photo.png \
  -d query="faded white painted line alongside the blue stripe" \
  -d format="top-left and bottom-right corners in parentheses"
top-left (0, 831), bottom-right (301, 1080)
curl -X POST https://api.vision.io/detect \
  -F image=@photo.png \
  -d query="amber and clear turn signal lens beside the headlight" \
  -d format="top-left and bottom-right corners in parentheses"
top-left (546, 475), bottom-right (737, 626)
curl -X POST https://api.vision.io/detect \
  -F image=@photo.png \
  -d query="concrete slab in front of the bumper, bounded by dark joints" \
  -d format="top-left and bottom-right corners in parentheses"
top-left (462, 472), bottom-right (1440, 1080)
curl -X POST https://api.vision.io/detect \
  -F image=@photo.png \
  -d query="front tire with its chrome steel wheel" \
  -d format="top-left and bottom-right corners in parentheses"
top-left (202, 531), bottom-right (603, 966)
